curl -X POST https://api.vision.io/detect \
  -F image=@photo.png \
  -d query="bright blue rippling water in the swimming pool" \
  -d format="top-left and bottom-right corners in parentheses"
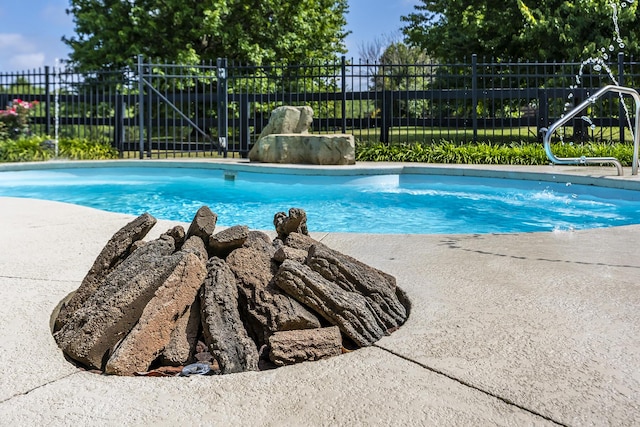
top-left (0, 167), bottom-right (640, 234)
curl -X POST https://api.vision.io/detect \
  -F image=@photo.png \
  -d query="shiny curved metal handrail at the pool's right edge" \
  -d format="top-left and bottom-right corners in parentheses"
top-left (540, 85), bottom-right (640, 175)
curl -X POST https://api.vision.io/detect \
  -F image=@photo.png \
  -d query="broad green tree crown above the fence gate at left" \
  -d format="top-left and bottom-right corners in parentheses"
top-left (63, 0), bottom-right (348, 71)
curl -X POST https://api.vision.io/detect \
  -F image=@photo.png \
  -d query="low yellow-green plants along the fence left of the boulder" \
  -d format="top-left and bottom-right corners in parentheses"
top-left (0, 136), bottom-right (118, 162)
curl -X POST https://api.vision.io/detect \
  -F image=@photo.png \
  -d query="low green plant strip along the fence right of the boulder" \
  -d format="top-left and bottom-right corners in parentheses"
top-left (356, 141), bottom-right (633, 166)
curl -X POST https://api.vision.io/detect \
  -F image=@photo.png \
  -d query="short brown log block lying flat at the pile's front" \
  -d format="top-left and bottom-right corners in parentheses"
top-left (269, 326), bottom-right (342, 366)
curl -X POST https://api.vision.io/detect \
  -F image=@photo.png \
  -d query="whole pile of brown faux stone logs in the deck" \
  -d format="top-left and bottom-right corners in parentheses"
top-left (54, 206), bottom-right (408, 375)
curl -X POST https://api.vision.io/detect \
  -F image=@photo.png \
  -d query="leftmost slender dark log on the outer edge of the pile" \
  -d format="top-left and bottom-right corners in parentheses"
top-left (54, 213), bottom-right (157, 331)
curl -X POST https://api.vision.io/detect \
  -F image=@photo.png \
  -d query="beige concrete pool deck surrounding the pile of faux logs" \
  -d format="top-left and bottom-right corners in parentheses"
top-left (0, 162), bottom-right (640, 426)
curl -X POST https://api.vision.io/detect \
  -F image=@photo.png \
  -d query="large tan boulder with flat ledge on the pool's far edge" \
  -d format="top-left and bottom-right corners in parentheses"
top-left (249, 106), bottom-right (356, 165)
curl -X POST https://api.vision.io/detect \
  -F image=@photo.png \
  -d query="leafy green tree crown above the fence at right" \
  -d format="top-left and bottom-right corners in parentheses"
top-left (401, 0), bottom-right (640, 62)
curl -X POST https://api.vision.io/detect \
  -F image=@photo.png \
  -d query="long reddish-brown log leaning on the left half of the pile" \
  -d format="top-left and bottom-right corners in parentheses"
top-left (105, 252), bottom-right (206, 375)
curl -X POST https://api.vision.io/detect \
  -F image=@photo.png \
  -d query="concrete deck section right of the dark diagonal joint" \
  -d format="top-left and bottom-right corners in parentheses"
top-left (323, 232), bottom-right (640, 425)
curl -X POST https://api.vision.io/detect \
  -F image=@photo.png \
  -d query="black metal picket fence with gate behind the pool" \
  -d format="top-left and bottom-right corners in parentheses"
top-left (0, 55), bottom-right (640, 157)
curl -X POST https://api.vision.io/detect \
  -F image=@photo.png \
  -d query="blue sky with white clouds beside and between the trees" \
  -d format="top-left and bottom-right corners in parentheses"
top-left (0, 0), bottom-right (419, 72)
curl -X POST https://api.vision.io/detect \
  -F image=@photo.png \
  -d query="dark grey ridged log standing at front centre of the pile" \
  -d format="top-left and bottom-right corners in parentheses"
top-left (200, 257), bottom-right (258, 374)
